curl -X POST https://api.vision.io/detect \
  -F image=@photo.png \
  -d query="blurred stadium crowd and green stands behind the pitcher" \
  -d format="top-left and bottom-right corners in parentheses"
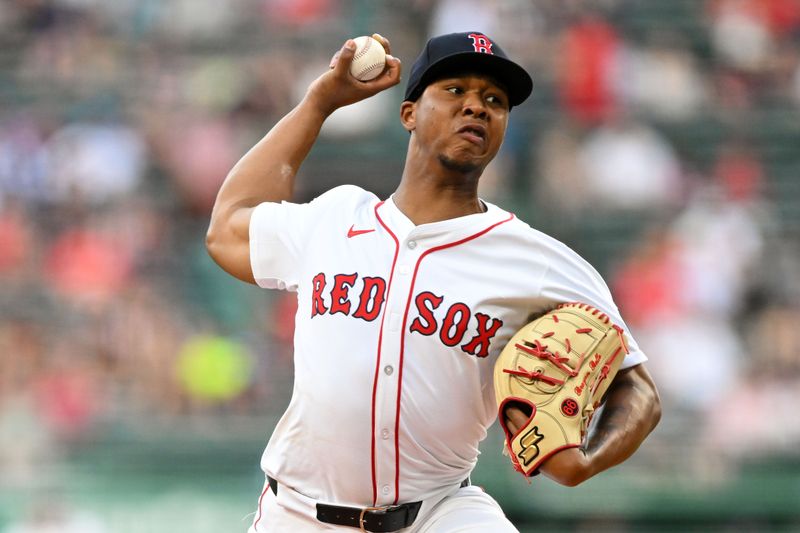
top-left (0, 0), bottom-right (800, 533)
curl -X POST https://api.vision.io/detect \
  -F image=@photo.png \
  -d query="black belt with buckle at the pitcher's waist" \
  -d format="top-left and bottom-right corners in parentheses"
top-left (267, 476), bottom-right (469, 533)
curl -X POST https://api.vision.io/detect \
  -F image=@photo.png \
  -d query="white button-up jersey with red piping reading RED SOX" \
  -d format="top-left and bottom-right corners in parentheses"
top-left (250, 185), bottom-right (645, 507)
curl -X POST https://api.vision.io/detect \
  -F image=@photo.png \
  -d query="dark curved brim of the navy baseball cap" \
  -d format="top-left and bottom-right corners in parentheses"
top-left (406, 52), bottom-right (533, 107)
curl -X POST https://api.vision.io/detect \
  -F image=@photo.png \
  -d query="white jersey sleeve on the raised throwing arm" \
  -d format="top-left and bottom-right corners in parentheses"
top-left (249, 185), bottom-right (370, 291)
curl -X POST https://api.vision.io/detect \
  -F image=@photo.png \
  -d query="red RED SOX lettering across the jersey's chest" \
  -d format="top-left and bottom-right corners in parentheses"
top-left (311, 272), bottom-right (503, 357)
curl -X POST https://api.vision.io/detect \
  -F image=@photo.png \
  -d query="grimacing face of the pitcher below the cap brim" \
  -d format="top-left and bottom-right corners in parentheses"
top-left (404, 74), bottom-right (508, 172)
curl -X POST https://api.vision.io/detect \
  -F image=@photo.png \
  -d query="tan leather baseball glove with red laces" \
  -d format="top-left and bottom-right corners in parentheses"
top-left (494, 302), bottom-right (628, 476)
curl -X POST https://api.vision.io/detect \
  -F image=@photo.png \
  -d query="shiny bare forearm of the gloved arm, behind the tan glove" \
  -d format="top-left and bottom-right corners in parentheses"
top-left (584, 366), bottom-right (661, 478)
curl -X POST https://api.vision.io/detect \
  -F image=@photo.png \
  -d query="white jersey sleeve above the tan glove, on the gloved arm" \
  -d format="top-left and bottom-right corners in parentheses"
top-left (541, 252), bottom-right (647, 368)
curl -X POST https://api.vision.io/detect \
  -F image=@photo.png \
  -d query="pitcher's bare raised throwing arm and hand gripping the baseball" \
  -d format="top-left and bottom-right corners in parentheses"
top-left (206, 35), bottom-right (400, 283)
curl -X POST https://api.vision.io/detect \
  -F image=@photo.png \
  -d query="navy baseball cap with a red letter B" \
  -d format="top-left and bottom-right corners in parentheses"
top-left (404, 31), bottom-right (533, 107)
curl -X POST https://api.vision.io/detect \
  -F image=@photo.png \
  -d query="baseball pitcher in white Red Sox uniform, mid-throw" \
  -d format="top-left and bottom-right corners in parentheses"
top-left (207, 32), bottom-right (660, 533)
